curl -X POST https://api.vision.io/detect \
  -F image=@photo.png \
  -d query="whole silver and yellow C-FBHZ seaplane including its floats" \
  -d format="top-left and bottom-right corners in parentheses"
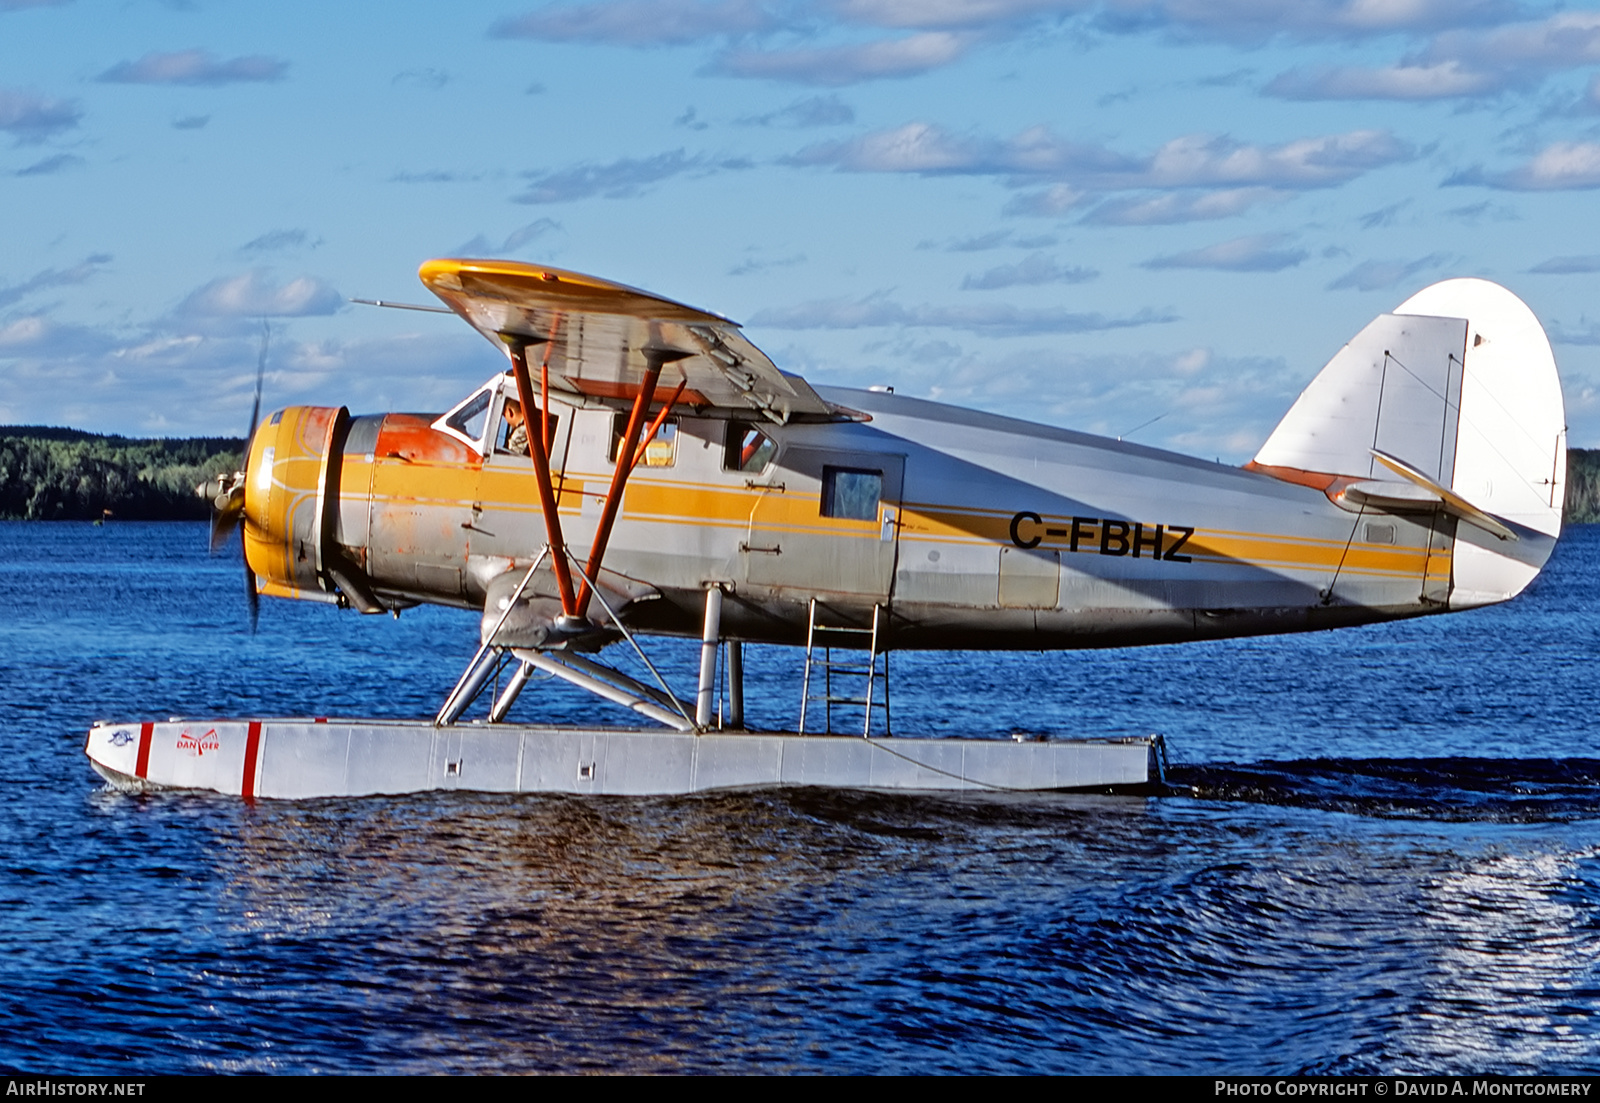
top-left (86, 259), bottom-right (1566, 799)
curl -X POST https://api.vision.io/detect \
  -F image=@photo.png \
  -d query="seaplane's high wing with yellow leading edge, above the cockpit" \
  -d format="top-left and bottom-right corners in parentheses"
top-left (418, 259), bottom-right (843, 424)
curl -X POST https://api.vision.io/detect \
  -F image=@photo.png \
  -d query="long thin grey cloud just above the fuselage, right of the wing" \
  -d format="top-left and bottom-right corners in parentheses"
top-left (749, 293), bottom-right (1178, 336)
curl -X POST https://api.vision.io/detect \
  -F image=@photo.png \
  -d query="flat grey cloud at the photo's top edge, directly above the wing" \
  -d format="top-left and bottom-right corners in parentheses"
top-left (490, 0), bottom-right (782, 46)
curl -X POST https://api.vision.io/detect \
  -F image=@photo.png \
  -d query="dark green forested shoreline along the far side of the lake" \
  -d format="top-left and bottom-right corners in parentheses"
top-left (0, 426), bottom-right (1600, 523)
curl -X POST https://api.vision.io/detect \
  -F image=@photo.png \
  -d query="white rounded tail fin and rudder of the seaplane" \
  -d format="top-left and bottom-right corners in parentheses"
top-left (1256, 279), bottom-right (1566, 608)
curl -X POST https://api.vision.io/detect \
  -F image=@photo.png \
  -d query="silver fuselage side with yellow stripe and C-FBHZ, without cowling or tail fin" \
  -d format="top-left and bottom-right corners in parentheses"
top-left (243, 384), bottom-right (1547, 648)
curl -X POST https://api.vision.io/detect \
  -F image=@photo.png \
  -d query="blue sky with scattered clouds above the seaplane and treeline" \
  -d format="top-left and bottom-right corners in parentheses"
top-left (0, 0), bottom-right (1600, 463)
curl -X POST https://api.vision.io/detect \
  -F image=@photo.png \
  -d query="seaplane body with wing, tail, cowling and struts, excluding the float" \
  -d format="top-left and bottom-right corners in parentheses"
top-left (91, 261), bottom-right (1565, 788)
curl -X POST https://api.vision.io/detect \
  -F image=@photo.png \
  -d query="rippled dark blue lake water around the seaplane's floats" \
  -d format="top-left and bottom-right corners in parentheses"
top-left (0, 523), bottom-right (1600, 1074)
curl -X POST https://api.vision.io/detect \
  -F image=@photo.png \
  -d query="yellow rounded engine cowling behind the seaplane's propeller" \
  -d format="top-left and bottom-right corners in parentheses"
top-left (243, 407), bottom-right (350, 602)
